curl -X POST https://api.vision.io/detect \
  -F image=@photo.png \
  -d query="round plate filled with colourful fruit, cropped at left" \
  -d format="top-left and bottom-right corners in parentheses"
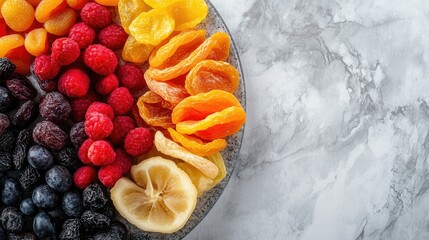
top-left (0, 0), bottom-right (242, 240)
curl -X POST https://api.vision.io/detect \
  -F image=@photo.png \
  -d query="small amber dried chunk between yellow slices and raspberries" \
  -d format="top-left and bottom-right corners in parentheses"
top-left (122, 36), bottom-right (154, 63)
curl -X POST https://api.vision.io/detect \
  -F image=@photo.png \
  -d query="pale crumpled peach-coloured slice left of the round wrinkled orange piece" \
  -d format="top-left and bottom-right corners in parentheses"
top-left (145, 71), bottom-right (189, 106)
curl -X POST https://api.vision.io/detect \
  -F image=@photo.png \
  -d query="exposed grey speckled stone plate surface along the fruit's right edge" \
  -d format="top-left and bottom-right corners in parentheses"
top-left (120, 0), bottom-right (246, 240)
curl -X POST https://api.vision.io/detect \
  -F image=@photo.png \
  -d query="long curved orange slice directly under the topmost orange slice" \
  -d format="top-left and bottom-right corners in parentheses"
top-left (147, 32), bottom-right (231, 81)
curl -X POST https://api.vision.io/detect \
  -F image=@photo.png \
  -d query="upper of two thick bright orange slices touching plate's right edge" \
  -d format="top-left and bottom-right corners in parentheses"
top-left (171, 90), bottom-right (241, 123)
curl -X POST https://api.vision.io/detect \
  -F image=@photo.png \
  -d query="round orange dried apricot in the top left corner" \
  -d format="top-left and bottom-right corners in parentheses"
top-left (1, 0), bottom-right (34, 32)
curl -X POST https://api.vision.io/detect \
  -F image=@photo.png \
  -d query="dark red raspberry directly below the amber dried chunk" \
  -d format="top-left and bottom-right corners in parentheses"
top-left (117, 63), bottom-right (145, 90)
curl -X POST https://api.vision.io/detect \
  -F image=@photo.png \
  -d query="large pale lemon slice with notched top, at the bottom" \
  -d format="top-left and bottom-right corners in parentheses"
top-left (110, 157), bottom-right (197, 233)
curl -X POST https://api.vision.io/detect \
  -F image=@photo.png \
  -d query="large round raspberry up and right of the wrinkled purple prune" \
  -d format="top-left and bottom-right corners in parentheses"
top-left (58, 68), bottom-right (91, 98)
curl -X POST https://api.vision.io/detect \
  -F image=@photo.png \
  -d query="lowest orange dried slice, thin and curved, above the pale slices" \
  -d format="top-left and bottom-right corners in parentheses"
top-left (167, 128), bottom-right (227, 156)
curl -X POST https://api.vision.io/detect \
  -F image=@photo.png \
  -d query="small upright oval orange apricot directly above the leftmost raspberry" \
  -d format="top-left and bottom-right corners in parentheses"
top-left (25, 28), bottom-right (49, 57)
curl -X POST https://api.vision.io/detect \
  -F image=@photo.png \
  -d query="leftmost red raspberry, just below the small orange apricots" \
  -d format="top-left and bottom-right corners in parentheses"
top-left (33, 54), bottom-right (61, 81)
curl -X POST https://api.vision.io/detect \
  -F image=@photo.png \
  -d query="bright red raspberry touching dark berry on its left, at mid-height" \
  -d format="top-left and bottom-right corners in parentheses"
top-left (85, 112), bottom-right (113, 140)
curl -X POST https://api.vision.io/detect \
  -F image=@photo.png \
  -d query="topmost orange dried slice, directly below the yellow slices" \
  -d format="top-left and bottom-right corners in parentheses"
top-left (149, 30), bottom-right (206, 68)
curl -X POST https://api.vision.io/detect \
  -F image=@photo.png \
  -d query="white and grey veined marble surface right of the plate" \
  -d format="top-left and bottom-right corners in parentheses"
top-left (186, 0), bottom-right (429, 240)
